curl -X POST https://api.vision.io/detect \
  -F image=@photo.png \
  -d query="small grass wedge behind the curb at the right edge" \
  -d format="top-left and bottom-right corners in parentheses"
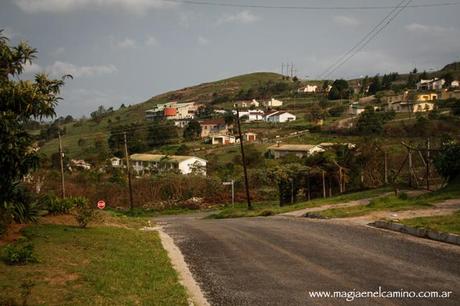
top-left (401, 211), bottom-right (460, 235)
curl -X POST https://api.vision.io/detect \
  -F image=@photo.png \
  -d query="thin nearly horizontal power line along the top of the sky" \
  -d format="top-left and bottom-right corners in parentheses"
top-left (163, 0), bottom-right (460, 11)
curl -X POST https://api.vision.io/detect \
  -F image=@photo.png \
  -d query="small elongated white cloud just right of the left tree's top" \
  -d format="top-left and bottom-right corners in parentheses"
top-left (46, 61), bottom-right (117, 78)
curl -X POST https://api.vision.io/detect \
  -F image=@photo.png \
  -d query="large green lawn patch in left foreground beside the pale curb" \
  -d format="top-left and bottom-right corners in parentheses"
top-left (0, 217), bottom-right (188, 305)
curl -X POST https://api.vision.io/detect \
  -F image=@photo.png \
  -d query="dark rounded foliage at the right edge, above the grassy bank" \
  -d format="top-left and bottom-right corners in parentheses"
top-left (433, 141), bottom-right (460, 181)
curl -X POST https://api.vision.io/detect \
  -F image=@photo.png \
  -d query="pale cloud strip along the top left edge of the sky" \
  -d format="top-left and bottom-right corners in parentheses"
top-left (14, 0), bottom-right (177, 13)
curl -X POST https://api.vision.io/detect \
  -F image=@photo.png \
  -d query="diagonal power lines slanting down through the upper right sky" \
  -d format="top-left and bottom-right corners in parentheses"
top-left (320, 0), bottom-right (412, 78)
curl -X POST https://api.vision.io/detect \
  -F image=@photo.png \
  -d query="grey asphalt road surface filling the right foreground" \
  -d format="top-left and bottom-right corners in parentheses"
top-left (156, 216), bottom-right (460, 305)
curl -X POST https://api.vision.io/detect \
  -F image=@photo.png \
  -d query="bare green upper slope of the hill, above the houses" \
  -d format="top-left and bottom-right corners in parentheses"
top-left (40, 72), bottom-right (283, 158)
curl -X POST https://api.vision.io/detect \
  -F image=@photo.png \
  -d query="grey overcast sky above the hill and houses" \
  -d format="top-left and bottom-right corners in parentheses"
top-left (0, 0), bottom-right (460, 116)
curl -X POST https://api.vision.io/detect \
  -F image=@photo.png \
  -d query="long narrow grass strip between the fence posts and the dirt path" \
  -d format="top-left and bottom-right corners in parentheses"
top-left (208, 188), bottom-right (391, 219)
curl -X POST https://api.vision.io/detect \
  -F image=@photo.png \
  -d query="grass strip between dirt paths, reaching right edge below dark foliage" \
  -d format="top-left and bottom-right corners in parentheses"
top-left (318, 183), bottom-right (460, 218)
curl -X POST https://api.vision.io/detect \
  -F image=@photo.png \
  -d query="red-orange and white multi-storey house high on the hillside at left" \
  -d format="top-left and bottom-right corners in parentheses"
top-left (145, 102), bottom-right (200, 120)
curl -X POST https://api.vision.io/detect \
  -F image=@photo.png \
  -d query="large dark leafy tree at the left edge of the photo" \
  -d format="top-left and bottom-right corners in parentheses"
top-left (0, 31), bottom-right (64, 207)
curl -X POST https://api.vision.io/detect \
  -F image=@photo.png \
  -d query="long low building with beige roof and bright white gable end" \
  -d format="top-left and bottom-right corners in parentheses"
top-left (130, 154), bottom-right (207, 176)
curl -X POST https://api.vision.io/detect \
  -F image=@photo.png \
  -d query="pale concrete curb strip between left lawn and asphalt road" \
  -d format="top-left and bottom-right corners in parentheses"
top-left (156, 227), bottom-right (210, 306)
